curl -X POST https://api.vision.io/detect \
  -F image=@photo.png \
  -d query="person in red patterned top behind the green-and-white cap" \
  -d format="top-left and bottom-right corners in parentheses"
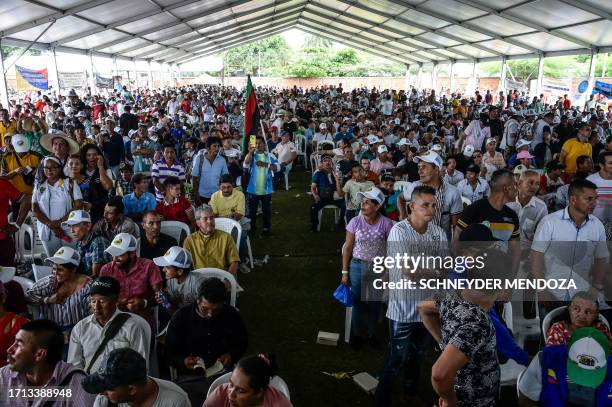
top-left (546, 291), bottom-right (612, 345)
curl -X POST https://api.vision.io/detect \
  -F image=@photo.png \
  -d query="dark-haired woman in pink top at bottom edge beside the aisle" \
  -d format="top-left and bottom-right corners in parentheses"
top-left (203, 353), bottom-right (293, 407)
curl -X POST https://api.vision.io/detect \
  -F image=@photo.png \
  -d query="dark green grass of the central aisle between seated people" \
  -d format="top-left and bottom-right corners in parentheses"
top-left (238, 167), bottom-right (516, 407)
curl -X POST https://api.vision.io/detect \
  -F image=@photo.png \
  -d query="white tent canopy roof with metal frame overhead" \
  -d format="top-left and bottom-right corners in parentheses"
top-left (0, 0), bottom-right (612, 65)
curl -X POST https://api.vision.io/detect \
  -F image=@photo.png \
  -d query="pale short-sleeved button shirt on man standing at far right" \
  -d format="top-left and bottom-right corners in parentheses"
top-left (531, 208), bottom-right (609, 301)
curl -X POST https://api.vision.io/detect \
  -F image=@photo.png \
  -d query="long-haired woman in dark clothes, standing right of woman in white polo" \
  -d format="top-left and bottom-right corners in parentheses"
top-left (80, 144), bottom-right (113, 223)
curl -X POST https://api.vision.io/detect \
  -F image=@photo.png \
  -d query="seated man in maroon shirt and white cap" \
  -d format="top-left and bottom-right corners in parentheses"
top-left (100, 233), bottom-right (162, 332)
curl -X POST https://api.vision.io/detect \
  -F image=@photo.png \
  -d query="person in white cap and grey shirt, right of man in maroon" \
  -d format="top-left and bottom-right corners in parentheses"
top-left (153, 246), bottom-right (206, 310)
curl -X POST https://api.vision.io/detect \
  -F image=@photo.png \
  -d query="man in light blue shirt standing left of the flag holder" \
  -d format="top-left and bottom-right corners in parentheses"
top-left (191, 137), bottom-right (229, 206)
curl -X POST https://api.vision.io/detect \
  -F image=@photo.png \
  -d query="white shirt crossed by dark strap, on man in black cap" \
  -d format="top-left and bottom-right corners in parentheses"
top-left (68, 310), bottom-right (151, 373)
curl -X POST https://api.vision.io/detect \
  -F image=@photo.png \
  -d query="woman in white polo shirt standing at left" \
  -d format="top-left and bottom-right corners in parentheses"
top-left (32, 157), bottom-right (83, 256)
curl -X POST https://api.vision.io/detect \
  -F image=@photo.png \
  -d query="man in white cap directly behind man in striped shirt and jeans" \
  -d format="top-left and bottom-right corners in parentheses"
top-left (397, 151), bottom-right (463, 239)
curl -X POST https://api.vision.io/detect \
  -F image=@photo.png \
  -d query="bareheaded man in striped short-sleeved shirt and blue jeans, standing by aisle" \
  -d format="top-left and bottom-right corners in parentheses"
top-left (376, 185), bottom-right (447, 407)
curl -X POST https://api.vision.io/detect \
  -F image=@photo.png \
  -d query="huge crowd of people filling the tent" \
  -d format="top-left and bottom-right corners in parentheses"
top-left (0, 84), bottom-right (612, 407)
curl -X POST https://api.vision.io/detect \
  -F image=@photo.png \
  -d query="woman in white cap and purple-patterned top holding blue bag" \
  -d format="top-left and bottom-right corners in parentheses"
top-left (341, 187), bottom-right (393, 349)
